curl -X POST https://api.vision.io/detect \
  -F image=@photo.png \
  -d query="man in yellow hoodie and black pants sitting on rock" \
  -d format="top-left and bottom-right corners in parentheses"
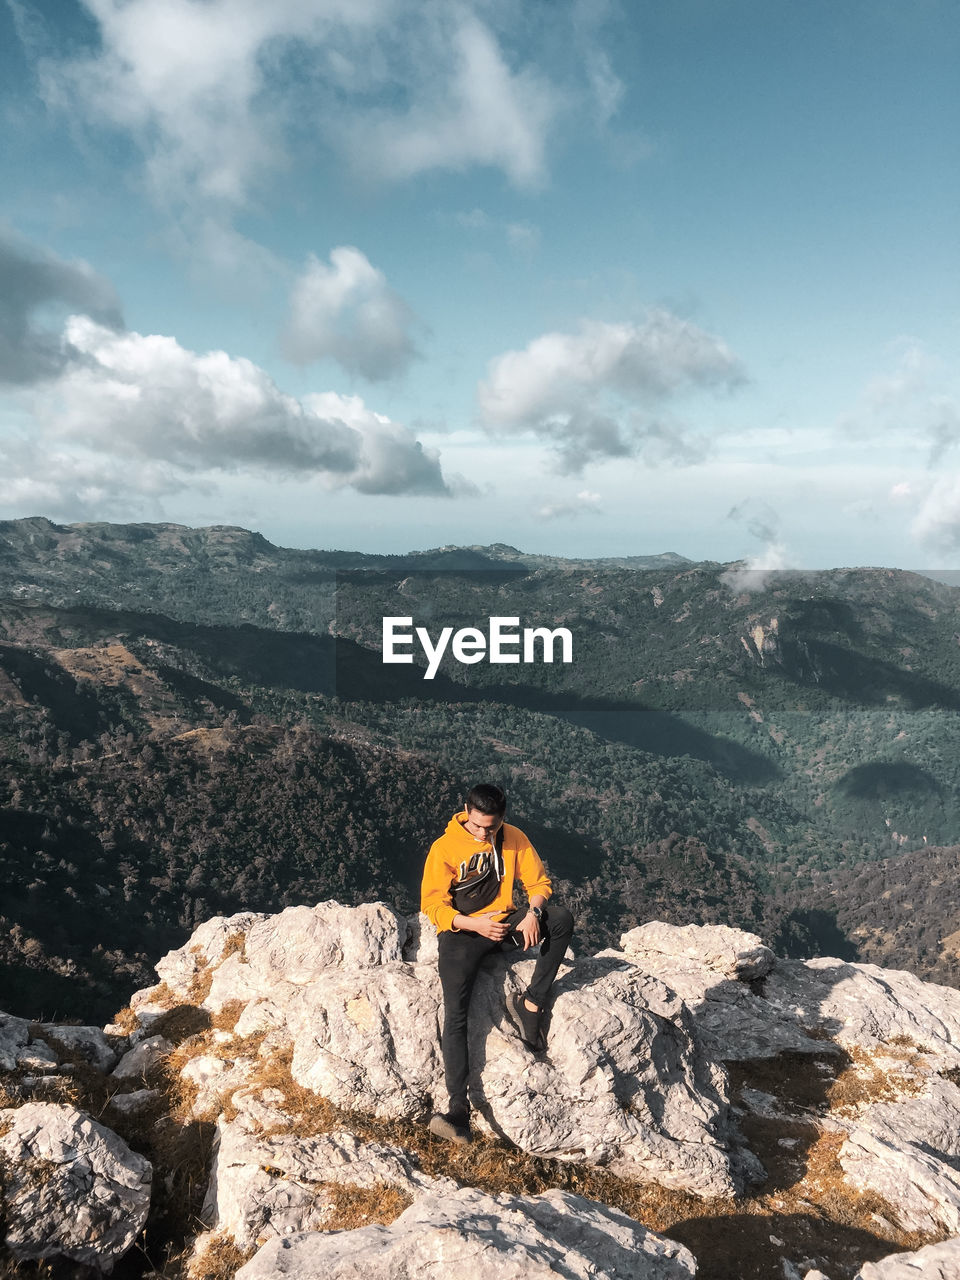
top-left (420, 782), bottom-right (573, 1143)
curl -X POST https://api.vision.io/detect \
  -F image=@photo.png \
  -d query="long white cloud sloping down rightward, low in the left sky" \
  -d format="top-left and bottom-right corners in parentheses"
top-left (20, 316), bottom-right (448, 494)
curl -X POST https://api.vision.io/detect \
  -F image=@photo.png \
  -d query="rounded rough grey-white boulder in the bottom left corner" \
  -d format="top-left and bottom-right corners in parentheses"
top-left (0, 1102), bottom-right (151, 1271)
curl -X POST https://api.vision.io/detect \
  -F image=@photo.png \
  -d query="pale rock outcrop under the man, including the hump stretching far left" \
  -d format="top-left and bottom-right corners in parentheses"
top-left (133, 904), bottom-right (755, 1196)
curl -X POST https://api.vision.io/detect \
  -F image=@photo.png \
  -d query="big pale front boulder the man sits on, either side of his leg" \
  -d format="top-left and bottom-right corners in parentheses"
top-left (281, 957), bottom-right (758, 1196)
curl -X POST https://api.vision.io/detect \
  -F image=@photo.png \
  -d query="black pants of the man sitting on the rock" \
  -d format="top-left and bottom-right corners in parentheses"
top-left (438, 902), bottom-right (573, 1117)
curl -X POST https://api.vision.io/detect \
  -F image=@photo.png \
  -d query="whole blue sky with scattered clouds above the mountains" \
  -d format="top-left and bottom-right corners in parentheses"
top-left (0, 0), bottom-right (960, 568)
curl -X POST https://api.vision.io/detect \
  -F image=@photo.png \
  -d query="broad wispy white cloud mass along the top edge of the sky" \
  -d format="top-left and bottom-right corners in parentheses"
top-left (40, 0), bottom-right (564, 209)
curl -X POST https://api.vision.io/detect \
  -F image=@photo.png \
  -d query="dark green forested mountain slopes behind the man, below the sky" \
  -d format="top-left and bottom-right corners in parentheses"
top-left (0, 520), bottom-right (960, 1012)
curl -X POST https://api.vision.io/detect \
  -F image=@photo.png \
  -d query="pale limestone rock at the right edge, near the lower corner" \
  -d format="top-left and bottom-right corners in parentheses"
top-left (840, 1076), bottom-right (960, 1234)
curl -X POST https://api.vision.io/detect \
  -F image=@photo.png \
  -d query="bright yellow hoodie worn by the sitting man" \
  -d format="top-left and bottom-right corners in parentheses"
top-left (420, 809), bottom-right (550, 933)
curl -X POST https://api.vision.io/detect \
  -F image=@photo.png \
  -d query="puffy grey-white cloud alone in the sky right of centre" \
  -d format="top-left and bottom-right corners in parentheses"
top-left (477, 310), bottom-right (745, 471)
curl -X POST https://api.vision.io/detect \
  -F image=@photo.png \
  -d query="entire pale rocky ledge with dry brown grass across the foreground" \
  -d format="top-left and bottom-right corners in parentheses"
top-left (0, 902), bottom-right (960, 1280)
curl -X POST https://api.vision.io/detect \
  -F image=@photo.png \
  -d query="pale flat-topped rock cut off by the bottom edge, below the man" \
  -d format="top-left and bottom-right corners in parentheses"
top-left (237, 1189), bottom-right (696, 1280)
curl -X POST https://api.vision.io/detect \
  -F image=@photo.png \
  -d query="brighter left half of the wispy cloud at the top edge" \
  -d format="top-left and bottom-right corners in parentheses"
top-left (41, 0), bottom-right (384, 205)
